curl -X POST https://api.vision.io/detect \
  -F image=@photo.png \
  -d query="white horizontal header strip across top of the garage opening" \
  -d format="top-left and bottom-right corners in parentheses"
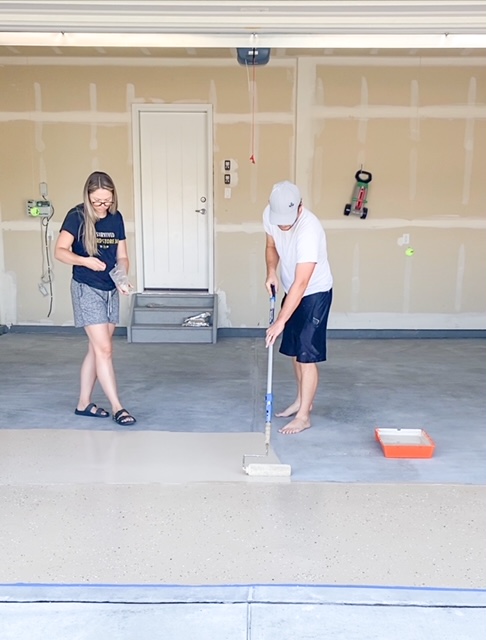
top-left (0, 0), bottom-right (486, 57)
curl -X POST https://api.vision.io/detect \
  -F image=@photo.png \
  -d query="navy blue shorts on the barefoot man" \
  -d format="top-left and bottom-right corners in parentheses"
top-left (279, 289), bottom-right (332, 362)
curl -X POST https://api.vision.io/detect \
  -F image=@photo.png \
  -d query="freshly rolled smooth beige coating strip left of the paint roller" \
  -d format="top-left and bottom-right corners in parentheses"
top-left (0, 429), bottom-right (289, 485)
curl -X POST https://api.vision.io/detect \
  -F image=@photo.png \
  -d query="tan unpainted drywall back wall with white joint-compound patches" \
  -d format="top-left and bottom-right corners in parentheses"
top-left (0, 55), bottom-right (486, 329)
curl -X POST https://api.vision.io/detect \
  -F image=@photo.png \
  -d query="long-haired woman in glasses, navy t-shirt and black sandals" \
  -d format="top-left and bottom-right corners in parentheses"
top-left (55, 171), bottom-right (136, 426)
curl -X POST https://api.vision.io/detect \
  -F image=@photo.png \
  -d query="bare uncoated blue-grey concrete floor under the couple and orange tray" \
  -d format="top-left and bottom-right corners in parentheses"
top-left (0, 333), bottom-right (486, 484)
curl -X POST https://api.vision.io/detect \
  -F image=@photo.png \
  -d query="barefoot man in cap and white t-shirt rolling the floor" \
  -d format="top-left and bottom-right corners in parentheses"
top-left (263, 181), bottom-right (332, 434)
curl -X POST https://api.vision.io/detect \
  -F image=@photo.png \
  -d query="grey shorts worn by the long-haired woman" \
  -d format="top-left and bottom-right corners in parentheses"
top-left (71, 280), bottom-right (120, 327)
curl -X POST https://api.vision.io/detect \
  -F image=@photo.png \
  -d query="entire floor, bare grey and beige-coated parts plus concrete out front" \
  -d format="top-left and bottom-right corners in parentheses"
top-left (0, 333), bottom-right (486, 640)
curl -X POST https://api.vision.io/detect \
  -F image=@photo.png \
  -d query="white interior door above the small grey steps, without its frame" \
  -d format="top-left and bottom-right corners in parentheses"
top-left (138, 106), bottom-right (212, 290)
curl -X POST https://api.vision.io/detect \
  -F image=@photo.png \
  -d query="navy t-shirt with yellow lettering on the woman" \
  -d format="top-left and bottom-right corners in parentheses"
top-left (61, 204), bottom-right (126, 291)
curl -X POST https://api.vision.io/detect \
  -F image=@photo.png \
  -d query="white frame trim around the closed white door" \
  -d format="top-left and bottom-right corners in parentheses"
top-left (132, 103), bottom-right (214, 294)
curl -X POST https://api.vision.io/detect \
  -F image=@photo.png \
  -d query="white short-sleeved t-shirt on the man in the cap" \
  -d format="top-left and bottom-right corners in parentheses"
top-left (263, 205), bottom-right (332, 296)
